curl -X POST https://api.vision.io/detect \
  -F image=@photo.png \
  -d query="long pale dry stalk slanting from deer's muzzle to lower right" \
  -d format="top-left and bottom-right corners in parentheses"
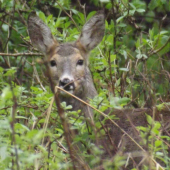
top-left (55, 86), bottom-right (164, 170)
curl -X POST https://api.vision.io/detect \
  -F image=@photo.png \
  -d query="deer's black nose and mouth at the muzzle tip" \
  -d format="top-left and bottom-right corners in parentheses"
top-left (59, 78), bottom-right (75, 91)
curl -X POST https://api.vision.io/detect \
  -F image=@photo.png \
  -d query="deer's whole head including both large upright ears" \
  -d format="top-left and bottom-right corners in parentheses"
top-left (28, 12), bottom-right (104, 96)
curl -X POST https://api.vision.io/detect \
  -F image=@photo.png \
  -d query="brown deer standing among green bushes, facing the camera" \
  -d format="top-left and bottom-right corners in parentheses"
top-left (28, 11), bottom-right (170, 169)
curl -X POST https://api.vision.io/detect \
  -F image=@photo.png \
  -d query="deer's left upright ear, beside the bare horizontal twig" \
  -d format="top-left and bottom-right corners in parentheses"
top-left (28, 12), bottom-right (57, 54)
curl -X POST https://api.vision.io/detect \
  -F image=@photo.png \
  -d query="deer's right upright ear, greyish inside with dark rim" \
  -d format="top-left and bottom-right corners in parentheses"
top-left (77, 11), bottom-right (105, 51)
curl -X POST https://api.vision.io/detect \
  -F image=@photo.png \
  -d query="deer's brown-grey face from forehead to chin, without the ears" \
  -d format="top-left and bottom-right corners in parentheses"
top-left (49, 44), bottom-right (87, 95)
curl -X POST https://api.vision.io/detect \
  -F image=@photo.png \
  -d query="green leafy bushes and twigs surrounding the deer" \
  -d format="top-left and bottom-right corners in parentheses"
top-left (0, 0), bottom-right (170, 170)
